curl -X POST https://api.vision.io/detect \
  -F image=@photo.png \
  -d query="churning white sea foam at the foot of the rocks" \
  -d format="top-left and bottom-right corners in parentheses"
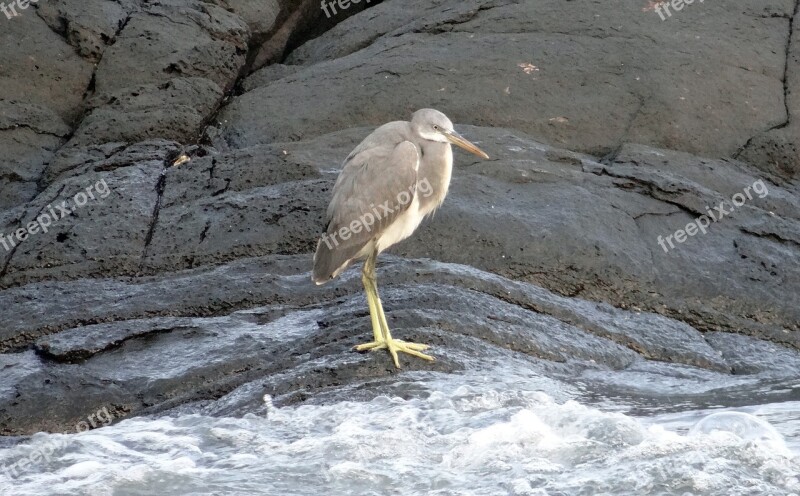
top-left (0, 364), bottom-right (800, 496)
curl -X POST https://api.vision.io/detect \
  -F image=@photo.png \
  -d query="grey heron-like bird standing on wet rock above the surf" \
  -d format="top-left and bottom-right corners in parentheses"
top-left (312, 108), bottom-right (489, 369)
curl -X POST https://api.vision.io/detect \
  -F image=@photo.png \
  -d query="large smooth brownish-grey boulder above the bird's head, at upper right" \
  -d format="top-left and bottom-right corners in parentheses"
top-left (220, 0), bottom-right (794, 161)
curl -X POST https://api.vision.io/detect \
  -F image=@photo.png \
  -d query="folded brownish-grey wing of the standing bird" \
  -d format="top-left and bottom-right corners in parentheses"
top-left (313, 141), bottom-right (420, 284)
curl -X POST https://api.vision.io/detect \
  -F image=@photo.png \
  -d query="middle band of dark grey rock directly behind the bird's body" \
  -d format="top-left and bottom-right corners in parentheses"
top-left (2, 128), bottom-right (800, 348)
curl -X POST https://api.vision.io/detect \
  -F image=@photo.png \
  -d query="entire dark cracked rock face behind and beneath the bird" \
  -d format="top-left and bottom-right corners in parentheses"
top-left (0, 0), bottom-right (800, 435)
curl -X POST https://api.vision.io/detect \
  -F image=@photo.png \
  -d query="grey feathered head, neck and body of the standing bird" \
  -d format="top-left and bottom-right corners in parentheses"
top-left (313, 109), bottom-right (488, 284)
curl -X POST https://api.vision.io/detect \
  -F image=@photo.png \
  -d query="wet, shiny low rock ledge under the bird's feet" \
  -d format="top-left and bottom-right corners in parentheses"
top-left (0, 255), bottom-right (776, 435)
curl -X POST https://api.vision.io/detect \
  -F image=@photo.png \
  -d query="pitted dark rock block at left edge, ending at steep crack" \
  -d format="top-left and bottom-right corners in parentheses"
top-left (0, 141), bottom-right (179, 284)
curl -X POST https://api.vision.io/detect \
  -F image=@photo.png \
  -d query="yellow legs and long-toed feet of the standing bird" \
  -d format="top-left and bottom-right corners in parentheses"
top-left (356, 252), bottom-right (433, 368)
